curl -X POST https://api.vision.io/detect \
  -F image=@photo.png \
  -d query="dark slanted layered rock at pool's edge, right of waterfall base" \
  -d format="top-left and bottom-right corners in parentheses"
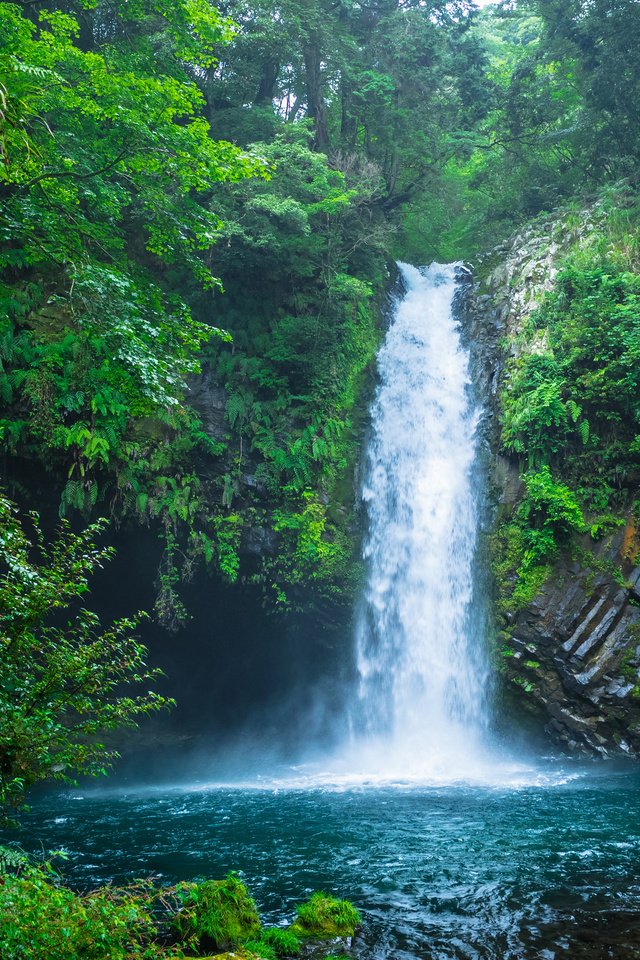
top-left (506, 522), bottom-right (640, 757)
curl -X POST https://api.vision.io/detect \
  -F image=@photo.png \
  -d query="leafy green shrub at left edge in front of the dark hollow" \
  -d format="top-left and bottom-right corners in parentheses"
top-left (0, 495), bottom-right (173, 817)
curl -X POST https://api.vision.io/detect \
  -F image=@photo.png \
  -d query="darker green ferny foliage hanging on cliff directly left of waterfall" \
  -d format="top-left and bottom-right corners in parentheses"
top-left (199, 125), bottom-right (388, 606)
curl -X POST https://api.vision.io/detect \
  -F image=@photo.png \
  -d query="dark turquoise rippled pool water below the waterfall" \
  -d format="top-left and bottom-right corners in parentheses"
top-left (8, 765), bottom-right (640, 960)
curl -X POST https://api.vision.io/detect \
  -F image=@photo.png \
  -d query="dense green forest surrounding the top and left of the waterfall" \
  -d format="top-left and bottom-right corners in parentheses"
top-left (0, 0), bottom-right (640, 626)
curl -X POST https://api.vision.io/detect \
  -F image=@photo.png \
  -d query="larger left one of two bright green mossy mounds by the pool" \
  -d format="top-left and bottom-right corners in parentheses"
top-left (174, 873), bottom-right (260, 958)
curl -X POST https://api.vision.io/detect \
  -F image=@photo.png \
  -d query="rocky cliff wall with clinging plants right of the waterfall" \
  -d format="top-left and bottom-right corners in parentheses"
top-left (465, 189), bottom-right (640, 756)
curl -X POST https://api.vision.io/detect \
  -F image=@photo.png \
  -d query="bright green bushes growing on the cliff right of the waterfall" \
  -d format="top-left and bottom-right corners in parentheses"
top-left (493, 251), bottom-right (640, 613)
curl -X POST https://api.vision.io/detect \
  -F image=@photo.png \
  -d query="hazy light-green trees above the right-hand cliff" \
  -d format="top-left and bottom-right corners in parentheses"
top-left (401, 0), bottom-right (640, 261)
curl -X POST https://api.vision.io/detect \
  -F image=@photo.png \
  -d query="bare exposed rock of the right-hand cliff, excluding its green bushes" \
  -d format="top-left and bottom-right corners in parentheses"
top-left (465, 202), bottom-right (640, 757)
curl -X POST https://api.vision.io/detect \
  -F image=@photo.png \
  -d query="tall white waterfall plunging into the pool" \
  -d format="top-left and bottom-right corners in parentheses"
top-left (352, 264), bottom-right (488, 779)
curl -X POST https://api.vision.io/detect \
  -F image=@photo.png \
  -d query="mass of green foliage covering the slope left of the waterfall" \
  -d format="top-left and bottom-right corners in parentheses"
top-left (0, 0), bottom-right (396, 612)
